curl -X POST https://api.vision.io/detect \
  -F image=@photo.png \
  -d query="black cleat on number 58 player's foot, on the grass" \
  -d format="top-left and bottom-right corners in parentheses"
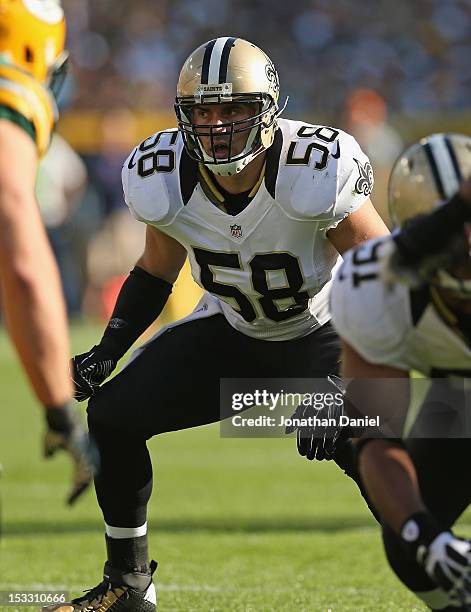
top-left (42, 561), bottom-right (157, 612)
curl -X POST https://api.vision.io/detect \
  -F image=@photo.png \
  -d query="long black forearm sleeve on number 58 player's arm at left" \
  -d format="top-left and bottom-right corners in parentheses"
top-left (100, 266), bottom-right (172, 360)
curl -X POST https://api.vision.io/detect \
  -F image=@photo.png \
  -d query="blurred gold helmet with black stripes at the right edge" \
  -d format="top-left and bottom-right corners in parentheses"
top-left (389, 134), bottom-right (471, 299)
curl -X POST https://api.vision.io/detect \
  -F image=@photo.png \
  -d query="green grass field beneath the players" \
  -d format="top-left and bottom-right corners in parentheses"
top-left (0, 325), bottom-right (444, 612)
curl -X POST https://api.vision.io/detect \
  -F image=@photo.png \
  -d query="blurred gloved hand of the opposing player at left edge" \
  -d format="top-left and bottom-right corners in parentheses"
top-left (44, 405), bottom-right (99, 505)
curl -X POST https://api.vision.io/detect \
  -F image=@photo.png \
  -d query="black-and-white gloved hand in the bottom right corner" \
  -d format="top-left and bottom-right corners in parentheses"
top-left (417, 531), bottom-right (471, 605)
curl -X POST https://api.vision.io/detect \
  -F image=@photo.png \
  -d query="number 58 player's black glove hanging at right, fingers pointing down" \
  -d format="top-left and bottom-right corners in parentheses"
top-left (285, 375), bottom-right (350, 461)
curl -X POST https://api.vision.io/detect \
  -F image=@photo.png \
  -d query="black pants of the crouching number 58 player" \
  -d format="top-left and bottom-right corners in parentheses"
top-left (88, 315), bottom-right (370, 527)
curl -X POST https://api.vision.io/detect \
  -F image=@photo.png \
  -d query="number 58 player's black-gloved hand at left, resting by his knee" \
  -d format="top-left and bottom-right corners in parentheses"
top-left (71, 344), bottom-right (117, 402)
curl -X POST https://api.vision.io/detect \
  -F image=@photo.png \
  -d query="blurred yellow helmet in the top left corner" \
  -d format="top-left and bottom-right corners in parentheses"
top-left (0, 0), bottom-right (67, 89)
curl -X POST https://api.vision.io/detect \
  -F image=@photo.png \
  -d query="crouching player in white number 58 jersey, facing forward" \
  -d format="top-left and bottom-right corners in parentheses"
top-left (51, 37), bottom-right (387, 612)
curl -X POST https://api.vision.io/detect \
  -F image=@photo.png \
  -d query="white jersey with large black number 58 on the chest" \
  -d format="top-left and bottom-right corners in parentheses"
top-left (122, 119), bottom-right (373, 340)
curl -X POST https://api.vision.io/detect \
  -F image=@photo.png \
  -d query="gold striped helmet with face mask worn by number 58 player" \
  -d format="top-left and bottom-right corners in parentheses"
top-left (175, 37), bottom-right (283, 176)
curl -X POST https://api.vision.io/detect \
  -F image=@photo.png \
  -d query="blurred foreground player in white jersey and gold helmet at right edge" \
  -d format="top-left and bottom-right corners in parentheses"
top-left (331, 134), bottom-right (471, 610)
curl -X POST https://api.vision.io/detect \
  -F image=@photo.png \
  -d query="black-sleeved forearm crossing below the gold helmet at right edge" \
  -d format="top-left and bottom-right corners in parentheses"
top-left (394, 193), bottom-right (471, 262)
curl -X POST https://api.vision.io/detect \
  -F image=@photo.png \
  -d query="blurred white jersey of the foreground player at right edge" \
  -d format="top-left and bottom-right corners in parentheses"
top-left (330, 236), bottom-right (471, 376)
